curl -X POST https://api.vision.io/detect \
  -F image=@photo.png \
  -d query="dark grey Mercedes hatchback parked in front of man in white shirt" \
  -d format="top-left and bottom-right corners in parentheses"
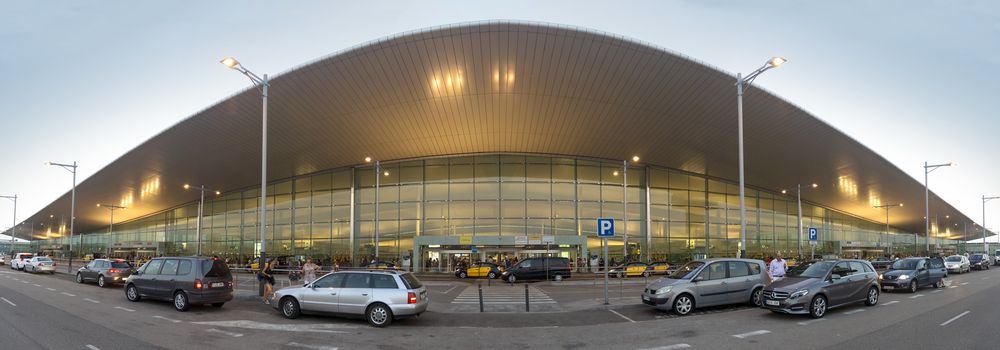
top-left (763, 259), bottom-right (879, 318)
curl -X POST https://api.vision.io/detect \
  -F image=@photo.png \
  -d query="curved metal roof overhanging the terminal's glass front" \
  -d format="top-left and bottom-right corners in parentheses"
top-left (13, 22), bottom-right (974, 238)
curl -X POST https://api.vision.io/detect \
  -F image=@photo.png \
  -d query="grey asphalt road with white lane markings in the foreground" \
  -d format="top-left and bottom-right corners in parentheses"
top-left (0, 268), bottom-right (1000, 350)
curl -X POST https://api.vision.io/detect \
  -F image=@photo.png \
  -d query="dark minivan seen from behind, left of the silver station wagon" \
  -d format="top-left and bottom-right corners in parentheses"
top-left (125, 256), bottom-right (233, 311)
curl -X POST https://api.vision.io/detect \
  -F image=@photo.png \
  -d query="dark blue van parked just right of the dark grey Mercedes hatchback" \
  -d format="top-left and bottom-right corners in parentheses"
top-left (879, 258), bottom-right (948, 293)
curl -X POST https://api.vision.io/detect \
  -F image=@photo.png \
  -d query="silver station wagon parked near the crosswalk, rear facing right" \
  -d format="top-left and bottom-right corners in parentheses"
top-left (271, 270), bottom-right (428, 327)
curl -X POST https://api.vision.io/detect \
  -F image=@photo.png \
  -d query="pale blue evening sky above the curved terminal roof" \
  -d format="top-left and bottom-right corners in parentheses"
top-left (0, 0), bottom-right (1000, 241)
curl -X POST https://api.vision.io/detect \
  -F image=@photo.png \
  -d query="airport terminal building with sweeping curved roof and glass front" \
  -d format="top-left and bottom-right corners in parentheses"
top-left (1, 22), bottom-right (977, 270)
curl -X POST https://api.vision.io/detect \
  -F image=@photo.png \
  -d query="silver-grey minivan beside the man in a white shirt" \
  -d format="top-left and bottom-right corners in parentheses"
top-left (642, 259), bottom-right (771, 316)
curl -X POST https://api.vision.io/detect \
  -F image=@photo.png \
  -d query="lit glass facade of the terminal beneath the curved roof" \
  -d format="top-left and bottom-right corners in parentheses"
top-left (29, 154), bottom-right (958, 266)
